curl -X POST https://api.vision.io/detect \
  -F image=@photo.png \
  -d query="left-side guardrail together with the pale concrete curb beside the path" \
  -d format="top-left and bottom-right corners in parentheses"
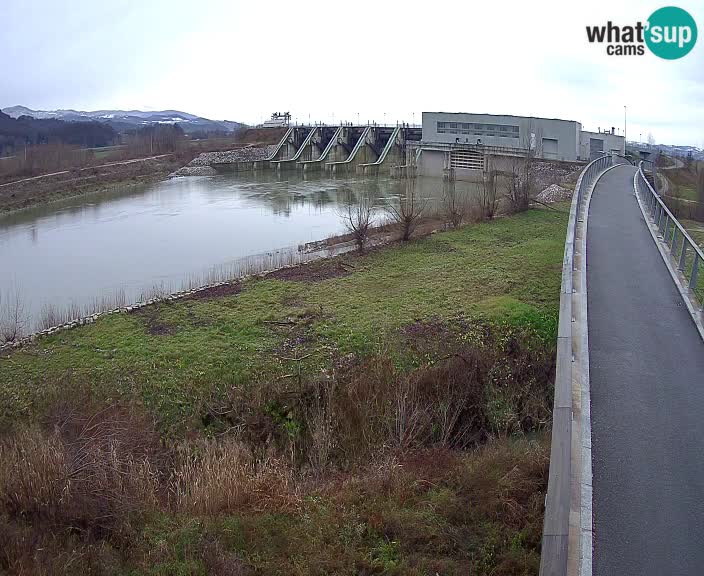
top-left (540, 156), bottom-right (612, 576)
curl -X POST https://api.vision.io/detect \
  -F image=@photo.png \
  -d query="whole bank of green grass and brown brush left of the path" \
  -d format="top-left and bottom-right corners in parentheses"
top-left (0, 205), bottom-right (568, 575)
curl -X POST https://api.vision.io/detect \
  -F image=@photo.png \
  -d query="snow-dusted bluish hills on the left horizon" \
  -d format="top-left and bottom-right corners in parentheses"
top-left (2, 106), bottom-right (247, 134)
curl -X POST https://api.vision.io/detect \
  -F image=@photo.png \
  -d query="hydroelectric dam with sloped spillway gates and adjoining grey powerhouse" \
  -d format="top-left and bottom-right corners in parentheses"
top-left (212, 112), bottom-right (625, 181)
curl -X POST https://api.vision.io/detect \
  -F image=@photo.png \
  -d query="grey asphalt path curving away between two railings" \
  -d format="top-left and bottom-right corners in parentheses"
top-left (587, 166), bottom-right (704, 576)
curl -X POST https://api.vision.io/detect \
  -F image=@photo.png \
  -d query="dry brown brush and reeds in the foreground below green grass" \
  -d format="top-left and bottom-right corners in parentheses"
top-left (0, 323), bottom-right (554, 574)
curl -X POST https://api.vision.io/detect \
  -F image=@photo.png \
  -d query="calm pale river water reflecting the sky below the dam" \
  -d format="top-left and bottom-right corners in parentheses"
top-left (0, 173), bottom-right (478, 328)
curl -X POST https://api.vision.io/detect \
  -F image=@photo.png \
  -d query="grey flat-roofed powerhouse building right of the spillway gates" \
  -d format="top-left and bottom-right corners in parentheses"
top-left (418, 112), bottom-right (625, 179)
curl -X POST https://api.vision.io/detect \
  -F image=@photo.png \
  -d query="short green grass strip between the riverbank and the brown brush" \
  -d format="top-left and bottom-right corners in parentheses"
top-left (0, 210), bottom-right (567, 430)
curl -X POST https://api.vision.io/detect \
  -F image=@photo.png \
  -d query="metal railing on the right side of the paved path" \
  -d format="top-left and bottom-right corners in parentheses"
top-left (635, 161), bottom-right (704, 298)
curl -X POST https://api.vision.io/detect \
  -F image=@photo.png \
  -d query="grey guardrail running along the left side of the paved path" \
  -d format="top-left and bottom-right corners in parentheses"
top-left (540, 155), bottom-right (614, 576)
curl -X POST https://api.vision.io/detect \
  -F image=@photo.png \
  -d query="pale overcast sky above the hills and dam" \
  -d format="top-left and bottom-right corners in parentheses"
top-left (0, 0), bottom-right (704, 147)
